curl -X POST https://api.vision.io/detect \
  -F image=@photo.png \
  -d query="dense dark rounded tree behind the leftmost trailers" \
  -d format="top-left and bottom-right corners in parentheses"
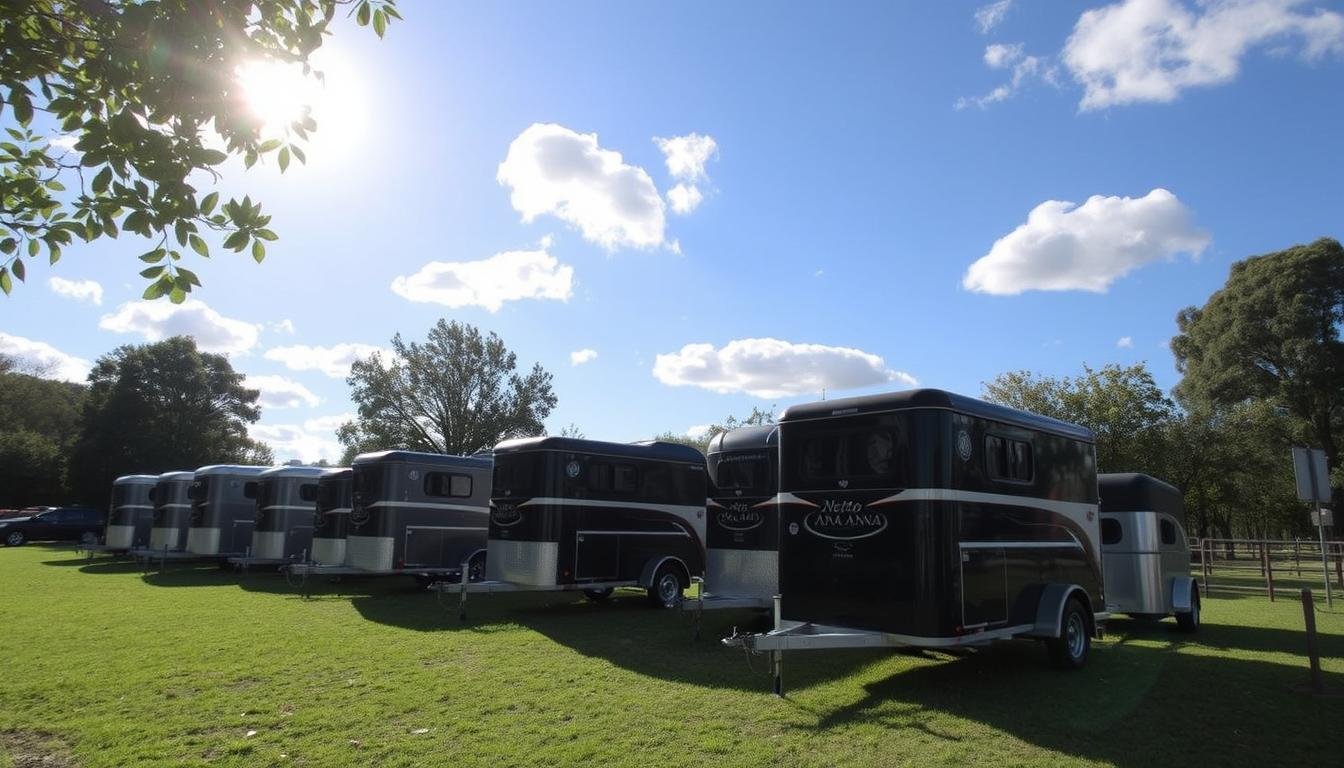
top-left (71, 336), bottom-right (270, 502)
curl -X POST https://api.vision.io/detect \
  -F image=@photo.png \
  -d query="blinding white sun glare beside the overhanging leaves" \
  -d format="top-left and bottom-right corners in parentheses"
top-left (237, 50), bottom-right (367, 157)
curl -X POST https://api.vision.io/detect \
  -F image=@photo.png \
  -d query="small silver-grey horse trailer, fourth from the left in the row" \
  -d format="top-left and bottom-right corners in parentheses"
top-left (228, 465), bottom-right (327, 569)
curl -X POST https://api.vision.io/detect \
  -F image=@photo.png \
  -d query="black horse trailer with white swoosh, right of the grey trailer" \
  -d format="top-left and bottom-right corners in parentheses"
top-left (443, 437), bottom-right (706, 620)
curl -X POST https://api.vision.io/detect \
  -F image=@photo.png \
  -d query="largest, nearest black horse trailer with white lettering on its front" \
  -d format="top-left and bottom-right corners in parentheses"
top-left (723, 389), bottom-right (1109, 693)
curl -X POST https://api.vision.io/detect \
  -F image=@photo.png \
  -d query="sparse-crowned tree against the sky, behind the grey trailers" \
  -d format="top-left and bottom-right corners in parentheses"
top-left (336, 320), bottom-right (556, 464)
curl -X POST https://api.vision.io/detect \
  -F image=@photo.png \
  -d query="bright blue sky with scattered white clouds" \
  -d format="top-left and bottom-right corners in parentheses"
top-left (0, 0), bottom-right (1344, 460)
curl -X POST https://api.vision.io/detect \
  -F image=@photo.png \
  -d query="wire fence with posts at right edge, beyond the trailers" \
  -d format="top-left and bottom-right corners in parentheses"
top-left (1191, 538), bottom-right (1344, 600)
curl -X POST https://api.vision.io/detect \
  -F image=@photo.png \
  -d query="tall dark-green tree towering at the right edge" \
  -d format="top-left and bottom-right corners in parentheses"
top-left (1172, 238), bottom-right (1344, 484)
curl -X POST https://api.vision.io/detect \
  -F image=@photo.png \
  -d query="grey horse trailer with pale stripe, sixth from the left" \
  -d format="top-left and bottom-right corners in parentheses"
top-left (345, 451), bottom-right (491, 585)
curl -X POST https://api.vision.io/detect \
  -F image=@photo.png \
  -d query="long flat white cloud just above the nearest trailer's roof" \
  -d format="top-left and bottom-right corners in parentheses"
top-left (653, 339), bottom-right (915, 397)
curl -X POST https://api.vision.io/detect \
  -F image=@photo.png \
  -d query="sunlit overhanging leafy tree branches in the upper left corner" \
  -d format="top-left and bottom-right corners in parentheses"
top-left (0, 0), bottom-right (401, 303)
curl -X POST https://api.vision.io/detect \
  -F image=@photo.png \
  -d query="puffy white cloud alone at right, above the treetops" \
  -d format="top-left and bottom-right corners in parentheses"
top-left (961, 188), bottom-right (1210, 295)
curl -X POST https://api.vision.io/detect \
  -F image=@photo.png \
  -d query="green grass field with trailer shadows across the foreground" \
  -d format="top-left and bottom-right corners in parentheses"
top-left (0, 546), bottom-right (1344, 768)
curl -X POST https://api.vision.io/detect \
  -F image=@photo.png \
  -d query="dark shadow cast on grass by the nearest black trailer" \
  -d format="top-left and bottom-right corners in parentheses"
top-left (785, 627), bottom-right (1344, 768)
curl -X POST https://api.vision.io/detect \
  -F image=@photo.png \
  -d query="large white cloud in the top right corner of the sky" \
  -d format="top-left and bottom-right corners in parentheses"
top-left (1062, 0), bottom-right (1344, 110)
